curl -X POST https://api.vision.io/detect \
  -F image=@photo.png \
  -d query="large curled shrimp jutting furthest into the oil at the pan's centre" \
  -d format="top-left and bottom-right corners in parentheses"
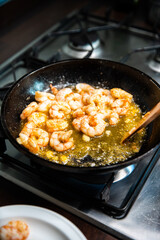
top-left (81, 116), bottom-right (106, 137)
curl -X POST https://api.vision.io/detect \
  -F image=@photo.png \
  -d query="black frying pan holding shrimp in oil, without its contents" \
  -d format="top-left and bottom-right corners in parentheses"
top-left (1, 59), bottom-right (160, 181)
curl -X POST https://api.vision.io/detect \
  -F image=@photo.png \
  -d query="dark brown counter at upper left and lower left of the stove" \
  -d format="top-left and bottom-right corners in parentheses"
top-left (0, 0), bottom-right (115, 240)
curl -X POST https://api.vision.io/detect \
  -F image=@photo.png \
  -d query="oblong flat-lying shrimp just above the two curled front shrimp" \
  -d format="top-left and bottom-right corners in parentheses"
top-left (46, 119), bottom-right (68, 133)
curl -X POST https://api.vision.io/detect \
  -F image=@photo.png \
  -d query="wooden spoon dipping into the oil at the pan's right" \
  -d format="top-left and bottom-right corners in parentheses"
top-left (121, 102), bottom-right (160, 143)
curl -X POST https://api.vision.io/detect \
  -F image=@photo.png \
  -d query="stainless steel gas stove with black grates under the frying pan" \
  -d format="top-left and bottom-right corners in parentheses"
top-left (0, 2), bottom-right (160, 240)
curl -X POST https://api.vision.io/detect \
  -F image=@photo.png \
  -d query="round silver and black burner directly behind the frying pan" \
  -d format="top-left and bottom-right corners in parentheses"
top-left (63, 32), bottom-right (100, 58)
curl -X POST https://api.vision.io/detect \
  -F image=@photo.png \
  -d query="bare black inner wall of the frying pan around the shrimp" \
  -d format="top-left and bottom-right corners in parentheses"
top-left (2, 59), bottom-right (160, 171)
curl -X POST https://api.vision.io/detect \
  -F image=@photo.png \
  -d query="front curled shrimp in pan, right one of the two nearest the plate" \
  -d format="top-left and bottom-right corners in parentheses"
top-left (50, 130), bottom-right (74, 152)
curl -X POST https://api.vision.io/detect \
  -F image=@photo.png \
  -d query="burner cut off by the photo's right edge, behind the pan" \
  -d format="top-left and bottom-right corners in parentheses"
top-left (148, 49), bottom-right (160, 73)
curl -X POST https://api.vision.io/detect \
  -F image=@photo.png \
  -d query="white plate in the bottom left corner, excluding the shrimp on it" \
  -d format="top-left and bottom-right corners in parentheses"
top-left (0, 205), bottom-right (86, 240)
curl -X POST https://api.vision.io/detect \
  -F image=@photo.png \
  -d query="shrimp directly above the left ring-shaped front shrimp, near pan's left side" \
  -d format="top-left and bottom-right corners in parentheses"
top-left (28, 112), bottom-right (48, 127)
